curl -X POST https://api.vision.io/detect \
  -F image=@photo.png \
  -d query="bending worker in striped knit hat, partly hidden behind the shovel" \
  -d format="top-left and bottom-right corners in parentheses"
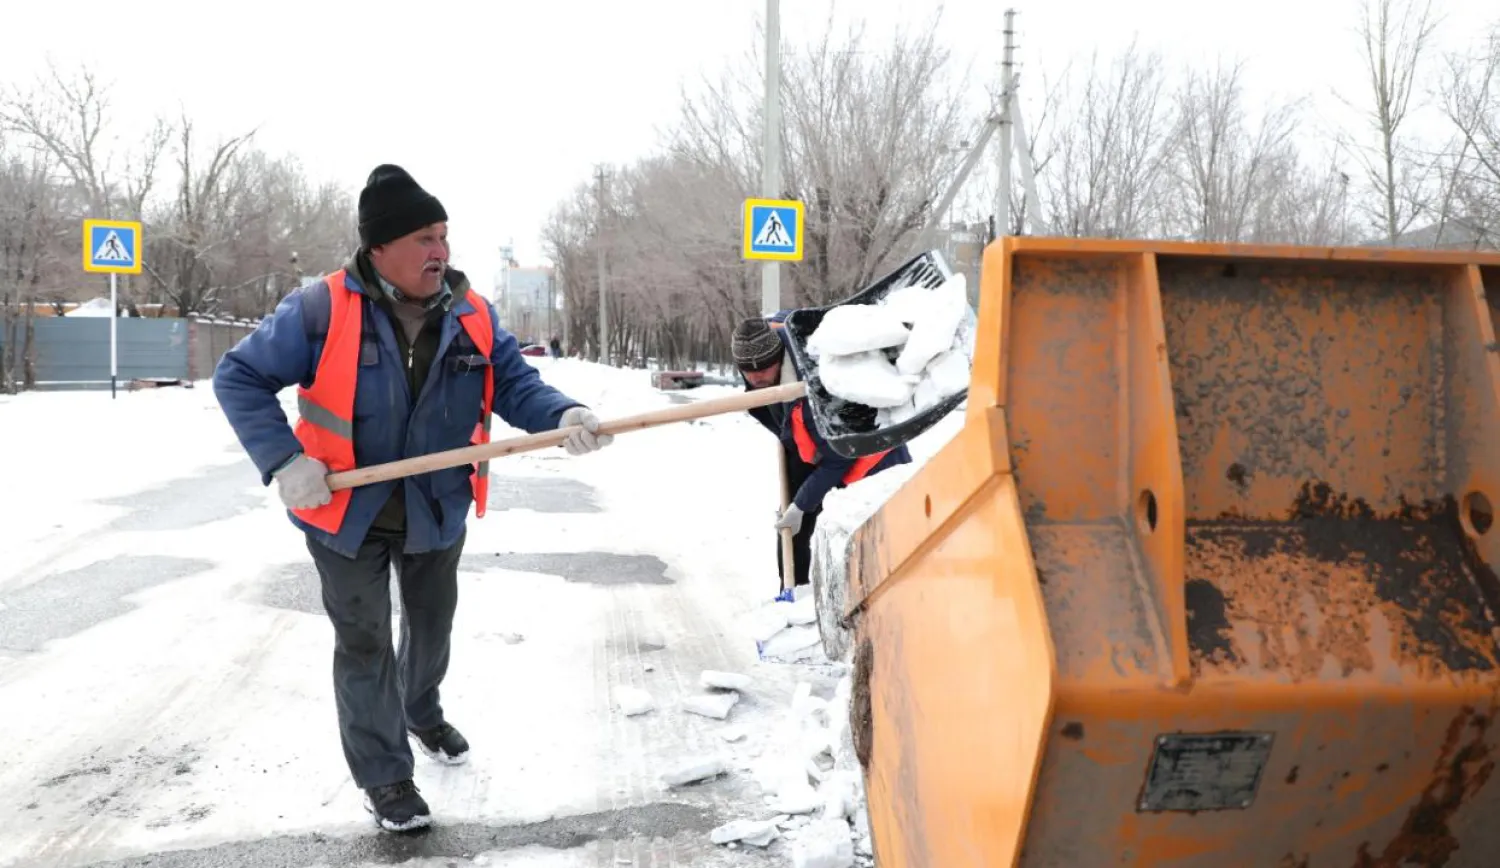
top-left (734, 310), bottom-right (912, 589)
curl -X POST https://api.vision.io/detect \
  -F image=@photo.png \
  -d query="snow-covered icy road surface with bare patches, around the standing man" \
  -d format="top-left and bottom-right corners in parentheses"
top-left (0, 360), bottom-right (960, 868)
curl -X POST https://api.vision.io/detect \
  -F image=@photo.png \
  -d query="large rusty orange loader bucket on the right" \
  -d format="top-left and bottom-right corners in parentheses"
top-left (845, 238), bottom-right (1500, 868)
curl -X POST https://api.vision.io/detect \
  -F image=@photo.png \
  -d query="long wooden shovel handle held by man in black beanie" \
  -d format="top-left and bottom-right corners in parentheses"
top-left (327, 382), bottom-right (807, 492)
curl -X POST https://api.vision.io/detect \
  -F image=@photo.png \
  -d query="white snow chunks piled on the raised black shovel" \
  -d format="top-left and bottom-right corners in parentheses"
top-left (807, 268), bottom-right (974, 427)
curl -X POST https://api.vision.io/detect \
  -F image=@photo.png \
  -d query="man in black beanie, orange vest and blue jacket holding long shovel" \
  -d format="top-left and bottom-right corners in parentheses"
top-left (213, 165), bottom-right (612, 831)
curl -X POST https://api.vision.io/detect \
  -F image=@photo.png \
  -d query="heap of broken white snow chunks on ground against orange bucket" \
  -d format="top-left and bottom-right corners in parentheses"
top-left (711, 675), bottom-right (875, 868)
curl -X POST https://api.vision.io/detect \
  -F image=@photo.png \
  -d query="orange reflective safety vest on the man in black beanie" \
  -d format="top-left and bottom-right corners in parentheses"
top-left (293, 268), bottom-right (495, 534)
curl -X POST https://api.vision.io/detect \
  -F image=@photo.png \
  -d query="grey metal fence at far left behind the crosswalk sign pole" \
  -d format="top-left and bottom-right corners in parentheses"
top-left (0, 316), bottom-right (254, 388)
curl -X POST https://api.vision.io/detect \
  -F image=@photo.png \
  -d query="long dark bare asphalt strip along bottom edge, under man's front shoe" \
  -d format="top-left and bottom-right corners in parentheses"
top-left (76, 802), bottom-right (719, 868)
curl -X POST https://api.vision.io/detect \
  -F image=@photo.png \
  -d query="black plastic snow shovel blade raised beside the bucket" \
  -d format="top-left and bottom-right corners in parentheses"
top-left (785, 250), bottom-right (969, 459)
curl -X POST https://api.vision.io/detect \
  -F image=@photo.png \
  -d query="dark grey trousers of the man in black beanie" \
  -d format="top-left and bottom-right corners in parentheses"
top-left (308, 534), bottom-right (465, 789)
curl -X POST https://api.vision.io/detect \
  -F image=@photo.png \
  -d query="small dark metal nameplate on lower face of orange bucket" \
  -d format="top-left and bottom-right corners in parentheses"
top-left (1137, 732), bottom-right (1274, 811)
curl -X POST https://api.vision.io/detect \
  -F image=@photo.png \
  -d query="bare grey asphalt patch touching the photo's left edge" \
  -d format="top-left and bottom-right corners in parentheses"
top-left (0, 555), bottom-right (215, 651)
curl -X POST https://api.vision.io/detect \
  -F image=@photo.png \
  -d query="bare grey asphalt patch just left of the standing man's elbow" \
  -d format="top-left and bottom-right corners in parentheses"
top-left (99, 460), bottom-right (264, 531)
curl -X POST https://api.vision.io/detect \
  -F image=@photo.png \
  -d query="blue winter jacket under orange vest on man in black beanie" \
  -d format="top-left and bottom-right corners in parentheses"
top-left (213, 268), bottom-right (581, 558)
